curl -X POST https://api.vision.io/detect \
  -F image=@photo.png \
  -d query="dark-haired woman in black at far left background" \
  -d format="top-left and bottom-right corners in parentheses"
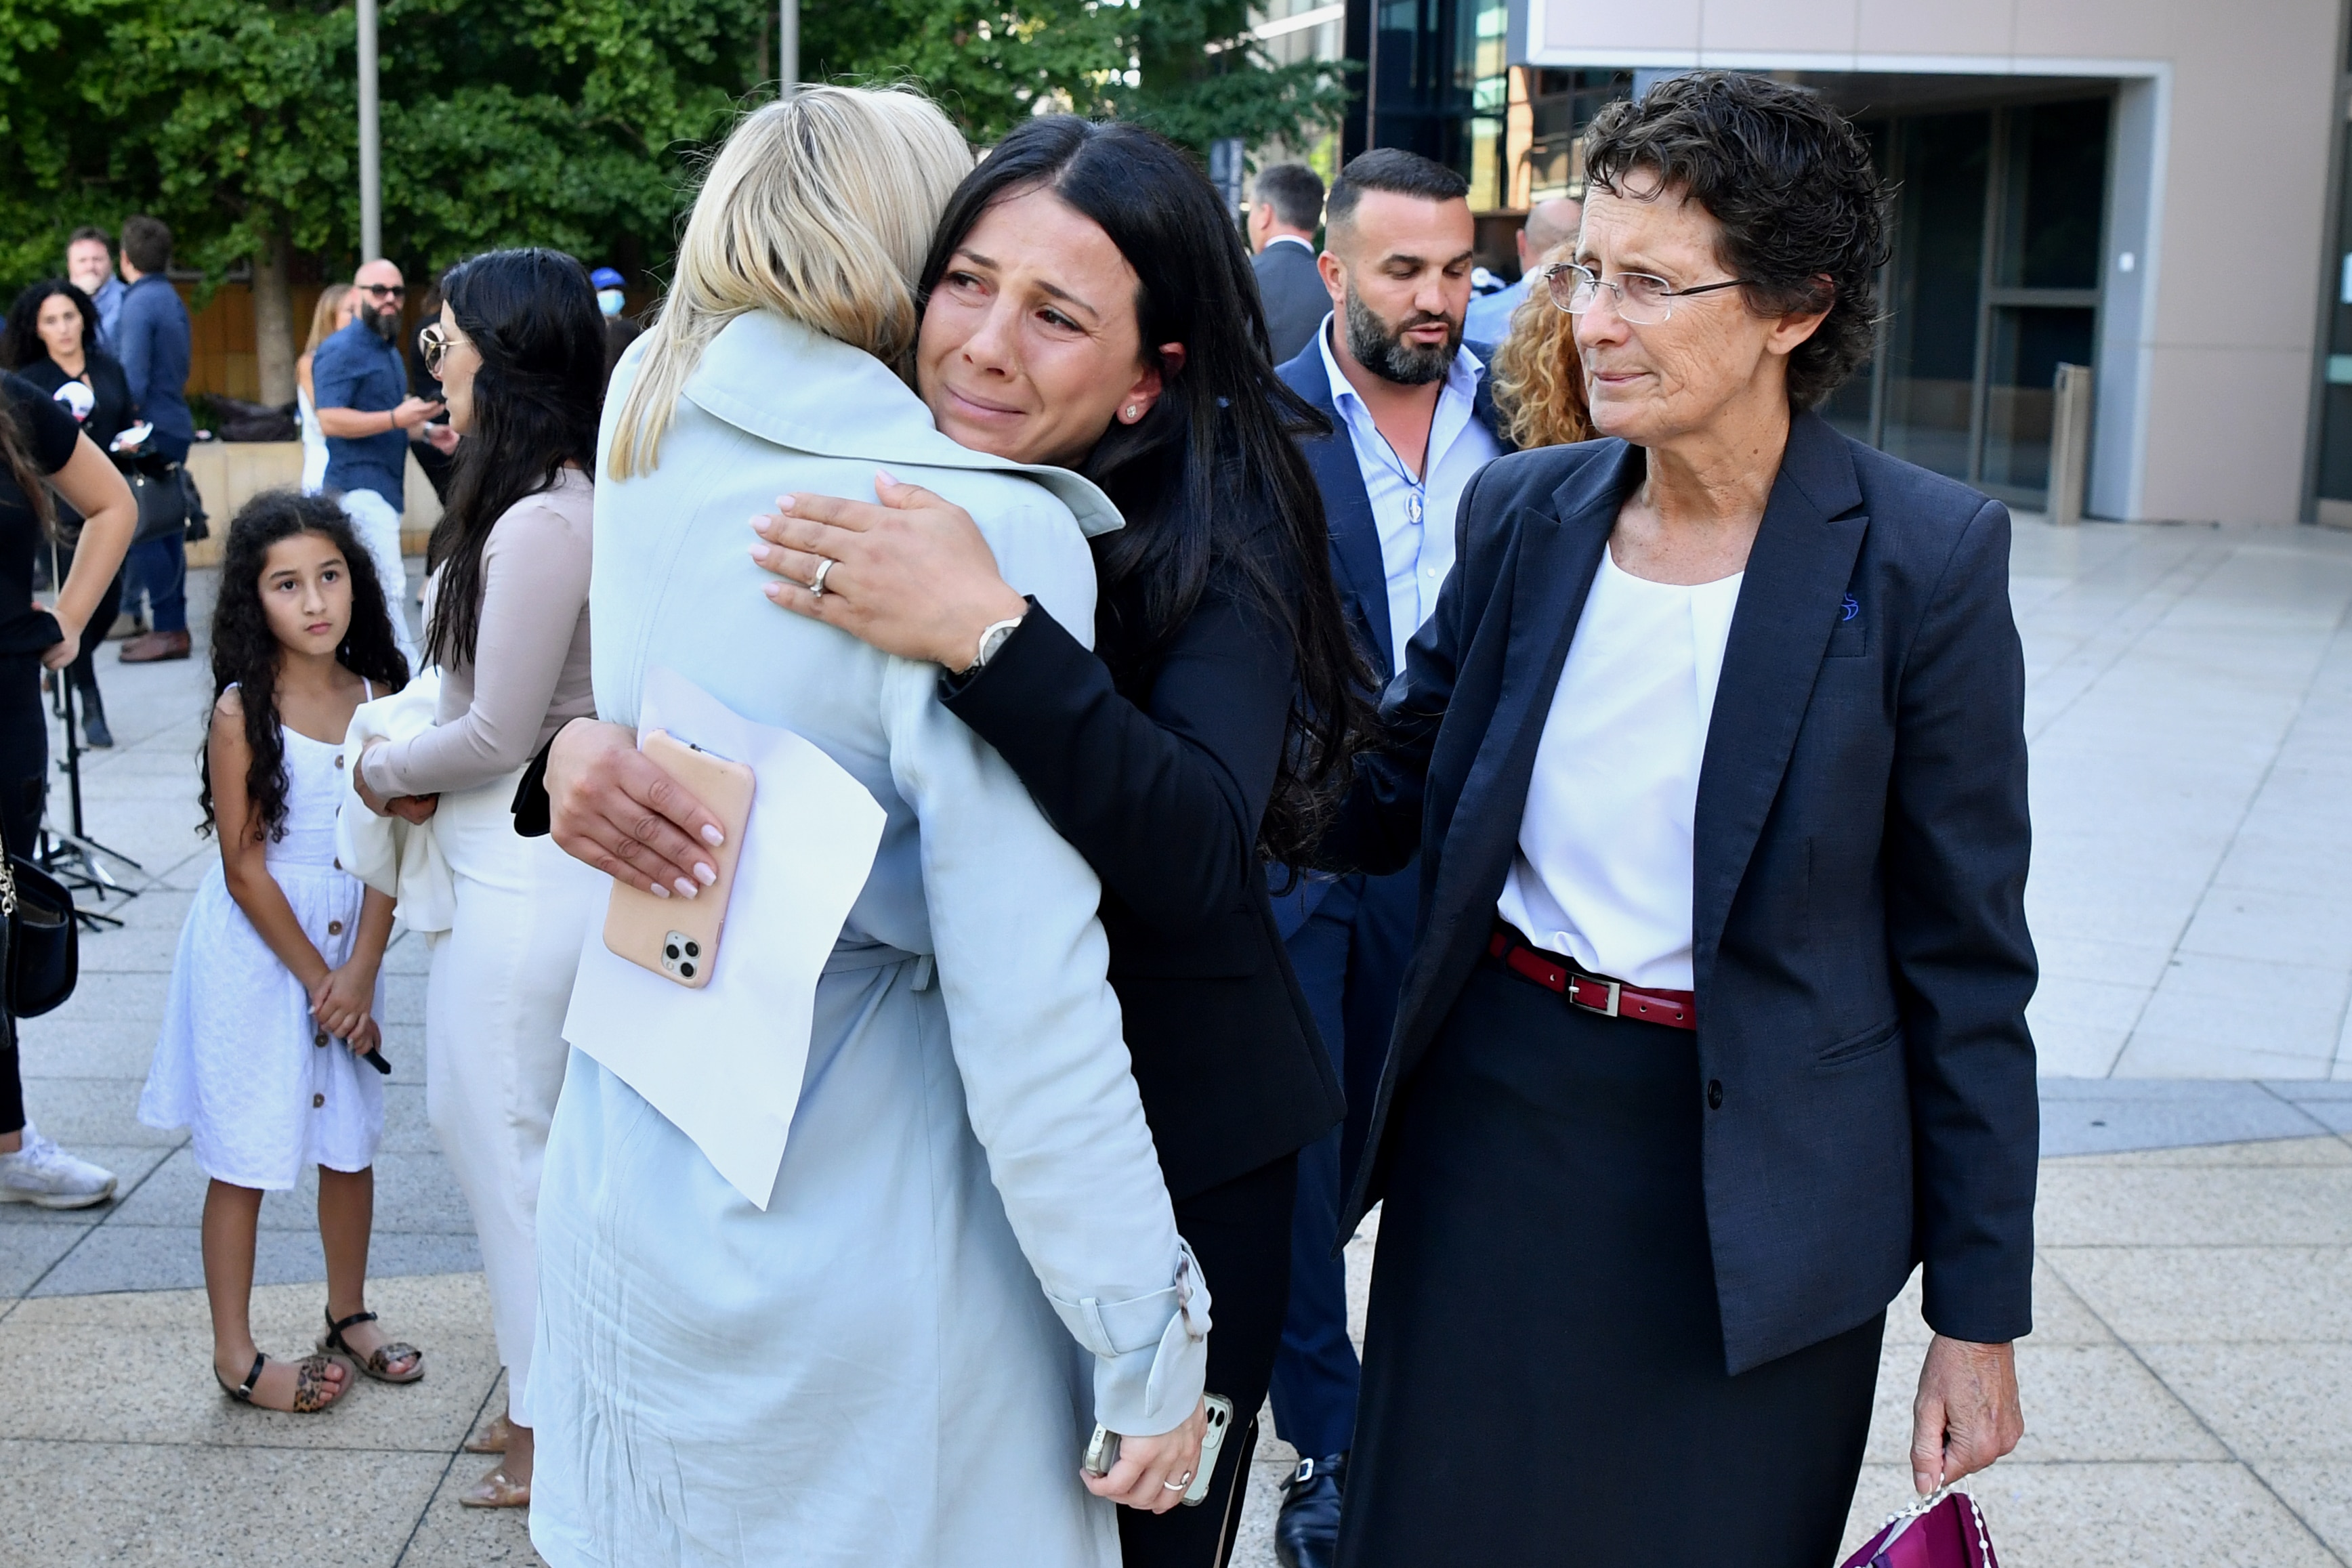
top-left (0, 278), bottom-right (139, 750)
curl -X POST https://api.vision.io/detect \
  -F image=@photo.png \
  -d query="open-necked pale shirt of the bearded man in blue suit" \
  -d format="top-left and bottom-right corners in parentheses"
top-left (1315, 315), bottom-right (1503, 670)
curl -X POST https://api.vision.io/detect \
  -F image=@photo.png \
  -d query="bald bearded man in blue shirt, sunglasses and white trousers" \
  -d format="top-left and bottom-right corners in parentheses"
top-left (310, 259), bottom-right (442, 670)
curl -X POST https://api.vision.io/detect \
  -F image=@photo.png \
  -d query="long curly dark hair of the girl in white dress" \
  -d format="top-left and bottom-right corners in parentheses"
top-left (198, 489), bottom-right (409, 842)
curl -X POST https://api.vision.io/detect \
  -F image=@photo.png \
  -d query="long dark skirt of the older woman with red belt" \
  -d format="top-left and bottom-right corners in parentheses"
top-left (1339, 962), bottom-right (1887, 1568)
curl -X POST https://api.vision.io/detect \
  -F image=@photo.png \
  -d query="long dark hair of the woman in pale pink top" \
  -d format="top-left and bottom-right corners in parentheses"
top-left (425, 247), bottom-right (604, 668)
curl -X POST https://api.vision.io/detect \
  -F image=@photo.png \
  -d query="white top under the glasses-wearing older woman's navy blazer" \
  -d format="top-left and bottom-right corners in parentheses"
top-left (1496, 548), bottom-right (1740, 990)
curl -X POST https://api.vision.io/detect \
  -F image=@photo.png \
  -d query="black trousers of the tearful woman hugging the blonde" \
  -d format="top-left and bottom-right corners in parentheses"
top-left (1120, 1154), bottom-right (1299, 1568)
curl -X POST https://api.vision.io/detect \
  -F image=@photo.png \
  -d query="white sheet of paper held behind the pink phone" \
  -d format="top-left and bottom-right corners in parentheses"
top-left (564, 670), bottom-right (887, 1210)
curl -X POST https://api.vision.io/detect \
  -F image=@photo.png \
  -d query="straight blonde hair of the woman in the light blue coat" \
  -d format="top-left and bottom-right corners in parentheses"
top-left (607, 87), bottom-right (971, 480)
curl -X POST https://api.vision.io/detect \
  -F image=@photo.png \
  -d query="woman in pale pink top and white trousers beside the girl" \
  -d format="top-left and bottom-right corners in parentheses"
top-left (358, 249), bottom-right (604, 1507)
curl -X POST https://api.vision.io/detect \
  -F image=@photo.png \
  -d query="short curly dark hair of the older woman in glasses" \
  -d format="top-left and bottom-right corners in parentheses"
top-left (1585, 70), bottom-right (1889, 409)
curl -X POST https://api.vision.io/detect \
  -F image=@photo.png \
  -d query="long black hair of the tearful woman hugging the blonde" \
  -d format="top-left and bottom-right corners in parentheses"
top-left (917, 115), bottom-right (1371, 863)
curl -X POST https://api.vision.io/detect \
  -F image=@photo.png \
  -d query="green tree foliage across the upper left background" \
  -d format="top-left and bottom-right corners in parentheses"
top-left (0, 0), bottom-right (1343, 312)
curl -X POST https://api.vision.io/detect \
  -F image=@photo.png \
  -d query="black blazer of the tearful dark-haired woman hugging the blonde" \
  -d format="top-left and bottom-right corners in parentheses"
top-left (941, 522), bottom-right (1343, 1199)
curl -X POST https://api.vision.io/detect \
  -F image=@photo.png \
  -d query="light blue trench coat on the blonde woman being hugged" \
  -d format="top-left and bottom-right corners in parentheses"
top-left (524, 315), bottom-right (1206, 1568)
